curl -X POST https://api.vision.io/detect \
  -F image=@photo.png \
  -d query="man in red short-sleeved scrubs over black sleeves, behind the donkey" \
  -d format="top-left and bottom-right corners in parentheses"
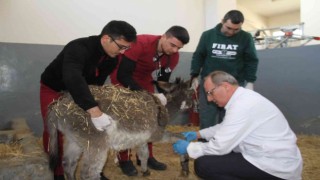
top-left (111, 26), bottom-right (189, 176)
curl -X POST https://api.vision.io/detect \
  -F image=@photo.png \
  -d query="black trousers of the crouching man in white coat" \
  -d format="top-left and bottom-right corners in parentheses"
top-left (194, 153), bottom-right (281, 180)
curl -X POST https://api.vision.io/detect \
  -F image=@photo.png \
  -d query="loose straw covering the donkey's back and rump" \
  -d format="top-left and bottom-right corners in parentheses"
top-left (49, 85), bottom-right (169, 131)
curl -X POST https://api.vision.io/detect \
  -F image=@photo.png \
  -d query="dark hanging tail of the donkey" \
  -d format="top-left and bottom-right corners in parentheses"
top-left (47, 111), bottom-right (59, 170)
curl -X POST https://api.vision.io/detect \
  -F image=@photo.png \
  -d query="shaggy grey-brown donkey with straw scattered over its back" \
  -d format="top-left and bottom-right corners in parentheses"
top-left (48, 81), bottom-right (191, 180)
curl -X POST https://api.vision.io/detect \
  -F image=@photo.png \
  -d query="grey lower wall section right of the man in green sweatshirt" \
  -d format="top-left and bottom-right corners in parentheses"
top-left (256, 45), bottom-right (320, 134)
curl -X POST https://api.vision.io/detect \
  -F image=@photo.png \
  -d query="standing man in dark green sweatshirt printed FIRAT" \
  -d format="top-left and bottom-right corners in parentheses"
top-left (190, 10), bottom-right (258, 129)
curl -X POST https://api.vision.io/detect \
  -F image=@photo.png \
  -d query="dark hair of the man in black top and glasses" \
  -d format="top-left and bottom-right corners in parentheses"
top-left (100, 20), bottom-right (137, 42)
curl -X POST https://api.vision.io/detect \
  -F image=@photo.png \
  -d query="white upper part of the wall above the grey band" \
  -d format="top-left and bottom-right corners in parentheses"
top-left (0, 0), bottom-right (320, 49)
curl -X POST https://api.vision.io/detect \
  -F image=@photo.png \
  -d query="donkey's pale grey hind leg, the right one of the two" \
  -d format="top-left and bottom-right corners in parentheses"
top-left (80, 144), bottom-right (108, 180)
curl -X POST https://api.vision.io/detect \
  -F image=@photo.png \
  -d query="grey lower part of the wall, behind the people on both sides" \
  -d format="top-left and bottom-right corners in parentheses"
top-left (0, 43), bottom-right (320, 135)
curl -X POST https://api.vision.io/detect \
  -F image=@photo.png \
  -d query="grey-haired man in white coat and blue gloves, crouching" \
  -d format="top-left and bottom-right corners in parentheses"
top-left (173, 71), bottom-right (302, 180)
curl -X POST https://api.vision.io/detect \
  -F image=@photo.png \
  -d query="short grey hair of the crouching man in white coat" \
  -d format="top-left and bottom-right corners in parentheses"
top-left (205, 71), bottom-right (239, 86)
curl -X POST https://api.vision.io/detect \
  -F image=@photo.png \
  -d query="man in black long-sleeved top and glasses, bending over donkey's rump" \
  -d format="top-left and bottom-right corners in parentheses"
top-left (40, 21), bottom-right (137, 179)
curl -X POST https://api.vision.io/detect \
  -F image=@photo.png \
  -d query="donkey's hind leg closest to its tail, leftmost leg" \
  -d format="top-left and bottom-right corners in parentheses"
top-left (63, 139), bottom-right (82, 180)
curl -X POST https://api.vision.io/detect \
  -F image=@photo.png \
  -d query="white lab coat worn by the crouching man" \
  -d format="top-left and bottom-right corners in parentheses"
top-left (187, 87), bottom-right (302, 180)
